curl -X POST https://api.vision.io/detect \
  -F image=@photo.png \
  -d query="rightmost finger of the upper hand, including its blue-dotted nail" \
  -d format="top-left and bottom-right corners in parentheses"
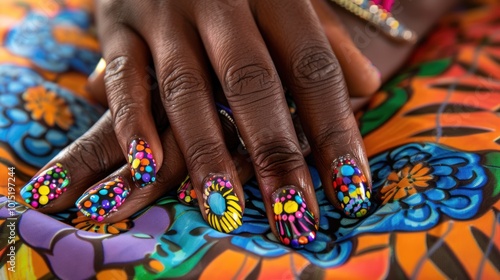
top-left (256, 0), bottom-right (371, 217)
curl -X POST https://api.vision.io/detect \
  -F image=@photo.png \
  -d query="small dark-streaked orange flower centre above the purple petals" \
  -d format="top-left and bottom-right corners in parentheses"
top-left (71, 212), bottom-right (132, 234)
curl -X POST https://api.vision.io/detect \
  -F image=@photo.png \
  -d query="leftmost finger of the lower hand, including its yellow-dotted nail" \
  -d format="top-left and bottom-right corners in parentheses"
top-left (20, 111), bottom-right (124, 213)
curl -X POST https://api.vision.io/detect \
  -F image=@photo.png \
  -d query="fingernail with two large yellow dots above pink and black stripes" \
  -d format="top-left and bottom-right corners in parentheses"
top-left (272, 186), bottom-right (318, 248)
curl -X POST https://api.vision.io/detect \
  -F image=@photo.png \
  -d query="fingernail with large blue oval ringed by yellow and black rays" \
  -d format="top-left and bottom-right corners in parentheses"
top-left (203, 174), bottom-right (243, 233)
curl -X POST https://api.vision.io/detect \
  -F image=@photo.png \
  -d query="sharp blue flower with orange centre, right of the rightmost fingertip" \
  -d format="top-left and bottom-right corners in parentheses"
top-left (339, 143), bottom-right (487, 238)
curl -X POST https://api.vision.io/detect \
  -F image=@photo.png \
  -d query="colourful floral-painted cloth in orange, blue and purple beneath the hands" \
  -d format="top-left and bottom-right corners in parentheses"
top-left (0, 0), bottom-right (500, 279)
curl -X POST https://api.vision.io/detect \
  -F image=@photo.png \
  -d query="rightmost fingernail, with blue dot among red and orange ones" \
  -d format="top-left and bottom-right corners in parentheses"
top-left (332, 155), bottom-right (371, 218)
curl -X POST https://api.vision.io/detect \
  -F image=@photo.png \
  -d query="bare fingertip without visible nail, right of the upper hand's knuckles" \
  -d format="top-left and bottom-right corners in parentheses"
top-left (311, 0), bottom-right (381, 96)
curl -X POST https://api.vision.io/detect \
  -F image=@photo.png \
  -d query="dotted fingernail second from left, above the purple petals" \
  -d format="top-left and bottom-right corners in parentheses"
top-left (75, 176), bottom-right (130, 222)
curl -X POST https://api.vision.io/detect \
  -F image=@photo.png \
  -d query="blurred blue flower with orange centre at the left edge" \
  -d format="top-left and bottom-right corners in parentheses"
top-left (0, 65), bottom-right (102, 167)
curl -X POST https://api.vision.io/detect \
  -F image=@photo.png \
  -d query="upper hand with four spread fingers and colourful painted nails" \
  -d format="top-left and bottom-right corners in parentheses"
top-left (22, 0), bottom-right (376, 247)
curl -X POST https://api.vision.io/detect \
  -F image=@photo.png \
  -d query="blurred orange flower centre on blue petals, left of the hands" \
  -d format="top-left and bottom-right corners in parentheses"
top-left (23, 86), bottom-right (73, 130)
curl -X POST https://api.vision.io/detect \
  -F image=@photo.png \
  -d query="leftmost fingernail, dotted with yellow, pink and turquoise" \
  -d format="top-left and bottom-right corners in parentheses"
top-left (21, 163), bottom-right (70, 209)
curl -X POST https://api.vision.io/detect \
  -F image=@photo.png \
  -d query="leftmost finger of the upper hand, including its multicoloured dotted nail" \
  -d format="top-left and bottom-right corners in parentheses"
top-left (97, 13), bottom-right (163, 187)
